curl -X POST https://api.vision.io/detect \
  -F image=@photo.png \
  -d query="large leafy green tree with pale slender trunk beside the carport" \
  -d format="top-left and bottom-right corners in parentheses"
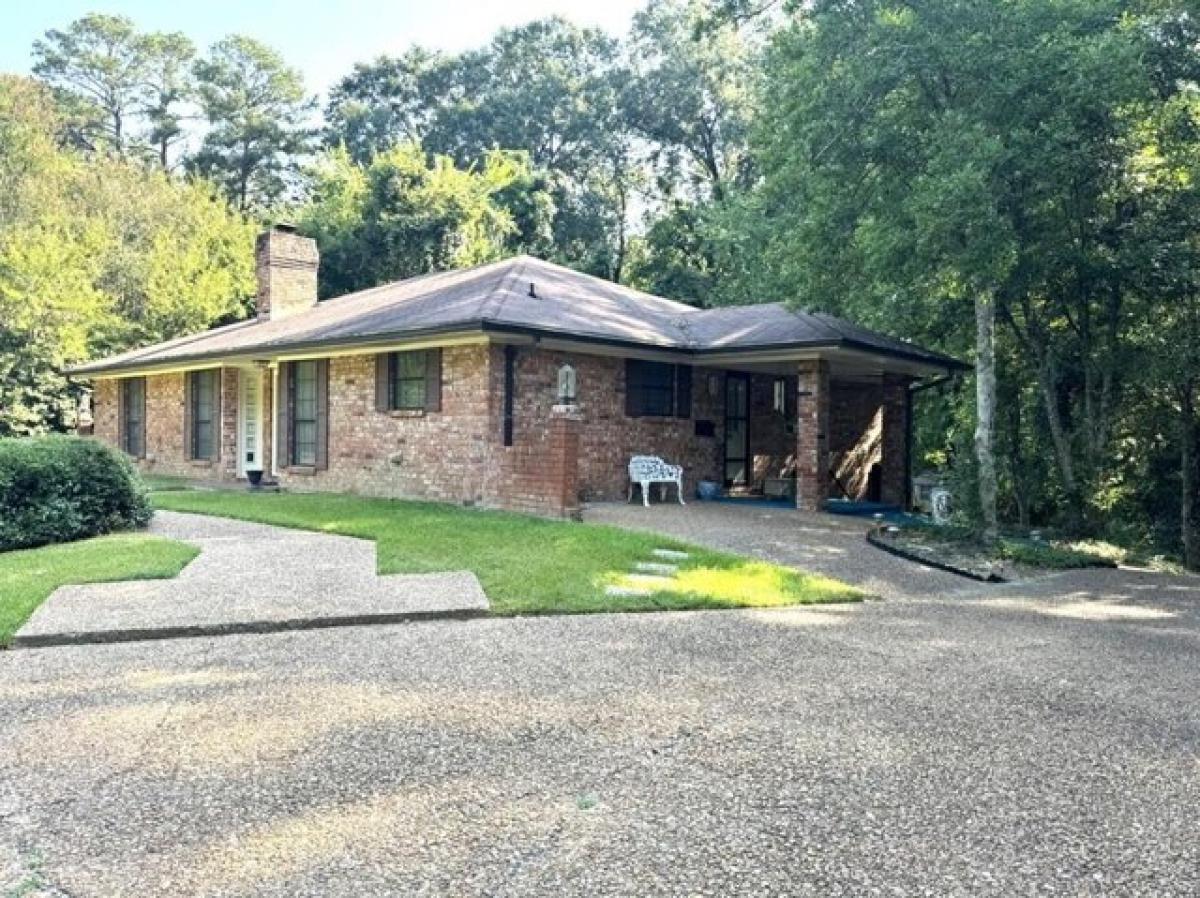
top-left (744, 0), bottom-right (1166, 534)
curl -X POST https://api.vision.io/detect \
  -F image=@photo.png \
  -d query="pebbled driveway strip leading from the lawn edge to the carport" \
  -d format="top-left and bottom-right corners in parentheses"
top-left (583, 502), bottom-right (976, 599)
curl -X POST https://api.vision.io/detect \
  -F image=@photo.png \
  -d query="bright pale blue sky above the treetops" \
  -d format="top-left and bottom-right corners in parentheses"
top-left (0, 0), bottom-right (644, 91)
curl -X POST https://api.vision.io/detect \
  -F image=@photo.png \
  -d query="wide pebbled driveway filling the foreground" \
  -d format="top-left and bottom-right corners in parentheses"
top-left (0, 571), bottom-right (1200, 898)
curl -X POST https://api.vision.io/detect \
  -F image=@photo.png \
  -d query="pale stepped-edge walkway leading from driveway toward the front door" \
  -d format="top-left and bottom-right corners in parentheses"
top-left (14, 511), bottom-right (488, 646)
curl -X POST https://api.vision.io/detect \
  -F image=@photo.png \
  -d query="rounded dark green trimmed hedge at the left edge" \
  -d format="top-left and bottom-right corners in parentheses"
top-left (0, 436), bottom-right (151, 551)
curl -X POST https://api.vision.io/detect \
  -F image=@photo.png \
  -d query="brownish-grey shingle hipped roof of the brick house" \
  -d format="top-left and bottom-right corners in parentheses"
top-left (73, 256), bottom-right (962, 373)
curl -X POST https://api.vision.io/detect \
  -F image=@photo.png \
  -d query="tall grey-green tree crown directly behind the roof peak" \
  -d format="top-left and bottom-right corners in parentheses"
top-left (326, 18), bottom-right (642, 277)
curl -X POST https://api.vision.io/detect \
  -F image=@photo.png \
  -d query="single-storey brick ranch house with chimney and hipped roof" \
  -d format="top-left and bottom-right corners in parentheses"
top-left (71, 227), bottom-right (964, 516)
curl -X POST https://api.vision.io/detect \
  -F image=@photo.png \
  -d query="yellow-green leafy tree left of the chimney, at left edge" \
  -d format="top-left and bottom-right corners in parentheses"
top-left (0, 76), bottom-right (254, 436)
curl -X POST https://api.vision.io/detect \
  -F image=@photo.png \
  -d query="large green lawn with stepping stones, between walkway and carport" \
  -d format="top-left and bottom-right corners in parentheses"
top-left (152, 491), bottom-right (863, 615)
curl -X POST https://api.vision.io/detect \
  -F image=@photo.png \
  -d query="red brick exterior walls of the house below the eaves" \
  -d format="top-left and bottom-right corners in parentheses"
top-left (94, 345), bottom-right (906, 514)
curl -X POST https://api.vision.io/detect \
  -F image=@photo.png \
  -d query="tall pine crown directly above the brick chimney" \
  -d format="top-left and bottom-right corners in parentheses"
top-left (191, 35), bottom-right (314, 211)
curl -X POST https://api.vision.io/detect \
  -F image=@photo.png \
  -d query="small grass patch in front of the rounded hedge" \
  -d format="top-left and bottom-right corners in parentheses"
top-left (0, 533), bottom-right (199, 646)
